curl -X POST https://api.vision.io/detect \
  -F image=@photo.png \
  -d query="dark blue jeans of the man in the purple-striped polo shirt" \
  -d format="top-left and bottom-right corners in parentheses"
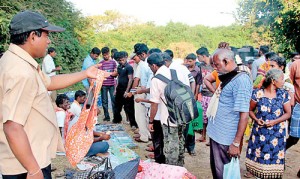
top-left (101, 86), bottom-right (115, 121)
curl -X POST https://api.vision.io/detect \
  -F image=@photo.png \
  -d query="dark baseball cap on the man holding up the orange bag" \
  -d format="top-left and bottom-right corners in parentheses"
top-left (9, 10), bottom-right (65, 35)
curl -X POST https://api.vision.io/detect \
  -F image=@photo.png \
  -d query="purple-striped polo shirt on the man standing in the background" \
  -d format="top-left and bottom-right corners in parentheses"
top-left (99, 60), bottom-right (117, 86)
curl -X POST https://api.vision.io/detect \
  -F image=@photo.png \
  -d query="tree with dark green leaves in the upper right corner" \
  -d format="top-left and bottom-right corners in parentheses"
top-left (238, 0), bottom-right (300, 54)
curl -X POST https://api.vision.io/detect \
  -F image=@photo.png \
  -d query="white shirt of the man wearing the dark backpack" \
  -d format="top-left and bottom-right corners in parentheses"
top-left (150, 65), bottom-right (189, 127)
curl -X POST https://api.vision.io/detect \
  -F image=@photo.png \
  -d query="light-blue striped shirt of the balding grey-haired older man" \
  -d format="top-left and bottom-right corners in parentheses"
top-left (207, 74), bottom-right (252, 145)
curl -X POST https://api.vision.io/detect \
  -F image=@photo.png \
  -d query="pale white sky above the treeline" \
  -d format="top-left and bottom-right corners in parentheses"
top-left (67, 0), bottom-right (237, 27)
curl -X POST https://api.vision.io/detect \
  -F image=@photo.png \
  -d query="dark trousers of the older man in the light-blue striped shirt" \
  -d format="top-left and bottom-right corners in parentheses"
top-left (210, 139), bottom-right (231, 179)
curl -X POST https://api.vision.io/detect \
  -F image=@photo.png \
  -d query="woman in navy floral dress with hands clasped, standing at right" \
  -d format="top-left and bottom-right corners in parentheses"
top-left (245, 69), bottom-right (291, 178)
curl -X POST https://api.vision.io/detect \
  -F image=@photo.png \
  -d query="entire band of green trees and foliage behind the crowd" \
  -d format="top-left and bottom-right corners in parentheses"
top-left (5, 0), bottom-right (300, 90)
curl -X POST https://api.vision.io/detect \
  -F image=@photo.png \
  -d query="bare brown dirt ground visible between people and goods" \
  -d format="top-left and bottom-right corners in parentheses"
top-left (52, 110), bottom-right (300, 179)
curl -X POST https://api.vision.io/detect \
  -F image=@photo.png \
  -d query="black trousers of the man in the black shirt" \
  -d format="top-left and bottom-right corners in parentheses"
top-left (113, 89), bottom-right (138, 127)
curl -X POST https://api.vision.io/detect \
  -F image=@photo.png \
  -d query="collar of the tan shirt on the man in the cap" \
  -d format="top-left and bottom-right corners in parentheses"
top-left (8, 43), bottom-right (39, 69)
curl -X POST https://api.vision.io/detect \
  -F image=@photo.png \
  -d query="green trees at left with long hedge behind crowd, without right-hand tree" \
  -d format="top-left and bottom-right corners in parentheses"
top-left (0, 0), bottom-right (258, 91)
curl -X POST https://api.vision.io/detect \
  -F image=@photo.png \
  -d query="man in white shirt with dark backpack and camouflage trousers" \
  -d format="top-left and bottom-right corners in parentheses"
top-left (147, 53), bottom-right (198, 166)
